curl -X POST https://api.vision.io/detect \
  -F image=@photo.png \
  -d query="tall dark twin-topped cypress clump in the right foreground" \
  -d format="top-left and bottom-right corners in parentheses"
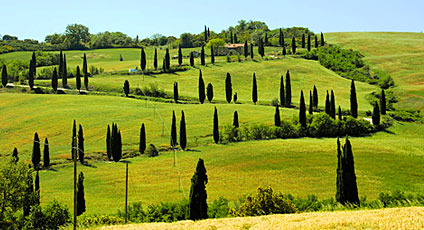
top-left (336, 136), bottom-right (360, 206)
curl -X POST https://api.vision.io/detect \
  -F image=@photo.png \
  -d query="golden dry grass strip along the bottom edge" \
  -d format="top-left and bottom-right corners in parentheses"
top-left (101, 207), bottom-right (424, 229)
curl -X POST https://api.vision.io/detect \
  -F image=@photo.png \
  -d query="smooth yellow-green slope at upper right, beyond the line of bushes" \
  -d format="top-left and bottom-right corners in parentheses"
top-left (325, 32), bottom-right (424, 111)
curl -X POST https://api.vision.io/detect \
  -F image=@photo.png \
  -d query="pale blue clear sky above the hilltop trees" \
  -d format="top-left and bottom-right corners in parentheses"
top-left (0, 0), bottom-right (424, 41)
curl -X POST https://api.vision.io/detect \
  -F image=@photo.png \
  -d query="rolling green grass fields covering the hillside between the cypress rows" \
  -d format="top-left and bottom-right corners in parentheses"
top-left (0, 33), bottom-right (424, 214)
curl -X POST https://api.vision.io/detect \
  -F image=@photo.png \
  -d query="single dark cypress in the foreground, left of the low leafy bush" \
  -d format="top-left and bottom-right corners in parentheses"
top-left (189, 158), bottom-right (208, 220)
